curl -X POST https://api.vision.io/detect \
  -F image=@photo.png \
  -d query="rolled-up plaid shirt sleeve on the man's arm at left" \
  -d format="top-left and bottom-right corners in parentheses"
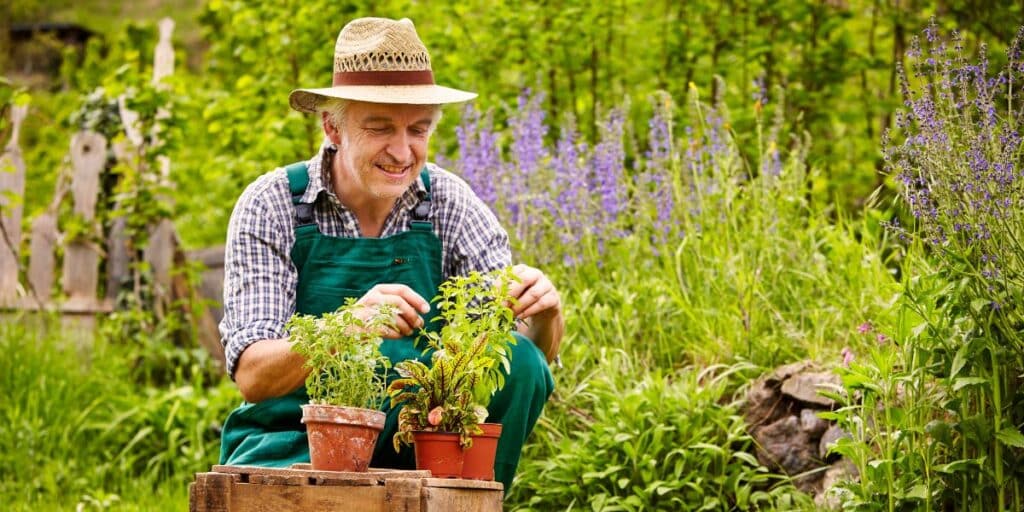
top-left (220, 170), bottom-right (298, 379)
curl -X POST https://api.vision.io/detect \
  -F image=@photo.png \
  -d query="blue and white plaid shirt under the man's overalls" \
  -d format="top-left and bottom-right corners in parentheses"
top-left (220, 143), bottom-right (512, 379)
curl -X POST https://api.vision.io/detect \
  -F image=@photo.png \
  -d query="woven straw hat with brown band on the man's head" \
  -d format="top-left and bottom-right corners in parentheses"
top-left (288, 17), bottom-right (476, 114)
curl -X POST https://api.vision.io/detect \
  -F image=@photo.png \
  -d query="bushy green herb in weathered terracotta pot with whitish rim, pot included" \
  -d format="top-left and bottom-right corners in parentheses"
top-left (287, 299), bottom-right (394, 471)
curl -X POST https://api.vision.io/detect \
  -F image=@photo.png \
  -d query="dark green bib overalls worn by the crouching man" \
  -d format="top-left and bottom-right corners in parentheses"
top-left (220, 162), bottom-right (554, 489)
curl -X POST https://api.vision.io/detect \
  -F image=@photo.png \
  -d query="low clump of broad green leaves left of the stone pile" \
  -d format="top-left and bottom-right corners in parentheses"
top-left (510, 350), bottom-right (809, 511)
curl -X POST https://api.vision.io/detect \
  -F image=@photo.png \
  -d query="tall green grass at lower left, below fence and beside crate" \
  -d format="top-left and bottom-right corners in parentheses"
top-left (0, 318), bottom-right (239, 510)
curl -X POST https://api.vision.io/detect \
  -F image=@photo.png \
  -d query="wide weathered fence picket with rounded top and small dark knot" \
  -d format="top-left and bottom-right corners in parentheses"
top-left (62, 132), bottom-right (106, 307)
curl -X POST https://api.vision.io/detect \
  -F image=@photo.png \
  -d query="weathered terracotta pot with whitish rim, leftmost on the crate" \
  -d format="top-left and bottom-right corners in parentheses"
top-left (302, 403), bottom-right (385, 471)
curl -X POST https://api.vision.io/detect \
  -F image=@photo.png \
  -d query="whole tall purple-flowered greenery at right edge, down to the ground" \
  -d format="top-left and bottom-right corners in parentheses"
top-left (823, 24), bottom-right (1024, 511)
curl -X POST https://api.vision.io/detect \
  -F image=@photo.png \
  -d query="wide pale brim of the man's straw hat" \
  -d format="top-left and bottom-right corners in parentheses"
top-left (288, 85), bottom-right (476, 114)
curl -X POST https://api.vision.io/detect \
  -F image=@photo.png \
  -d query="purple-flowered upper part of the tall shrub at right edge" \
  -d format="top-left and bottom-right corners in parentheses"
top-left (884, 23), bottom-right (1024, 354)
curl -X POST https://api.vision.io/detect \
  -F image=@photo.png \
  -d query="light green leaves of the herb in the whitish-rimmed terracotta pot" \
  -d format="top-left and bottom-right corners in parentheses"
top-left (285, 298), bottom-right (395, 410)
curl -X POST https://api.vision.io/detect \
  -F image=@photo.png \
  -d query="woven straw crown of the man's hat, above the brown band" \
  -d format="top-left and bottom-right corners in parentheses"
top-left (334, 17), bottom-right (430, 73)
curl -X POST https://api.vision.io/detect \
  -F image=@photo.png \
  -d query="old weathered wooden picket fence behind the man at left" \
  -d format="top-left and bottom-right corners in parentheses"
top-left (0, 18), bottom-right (223, 364)
